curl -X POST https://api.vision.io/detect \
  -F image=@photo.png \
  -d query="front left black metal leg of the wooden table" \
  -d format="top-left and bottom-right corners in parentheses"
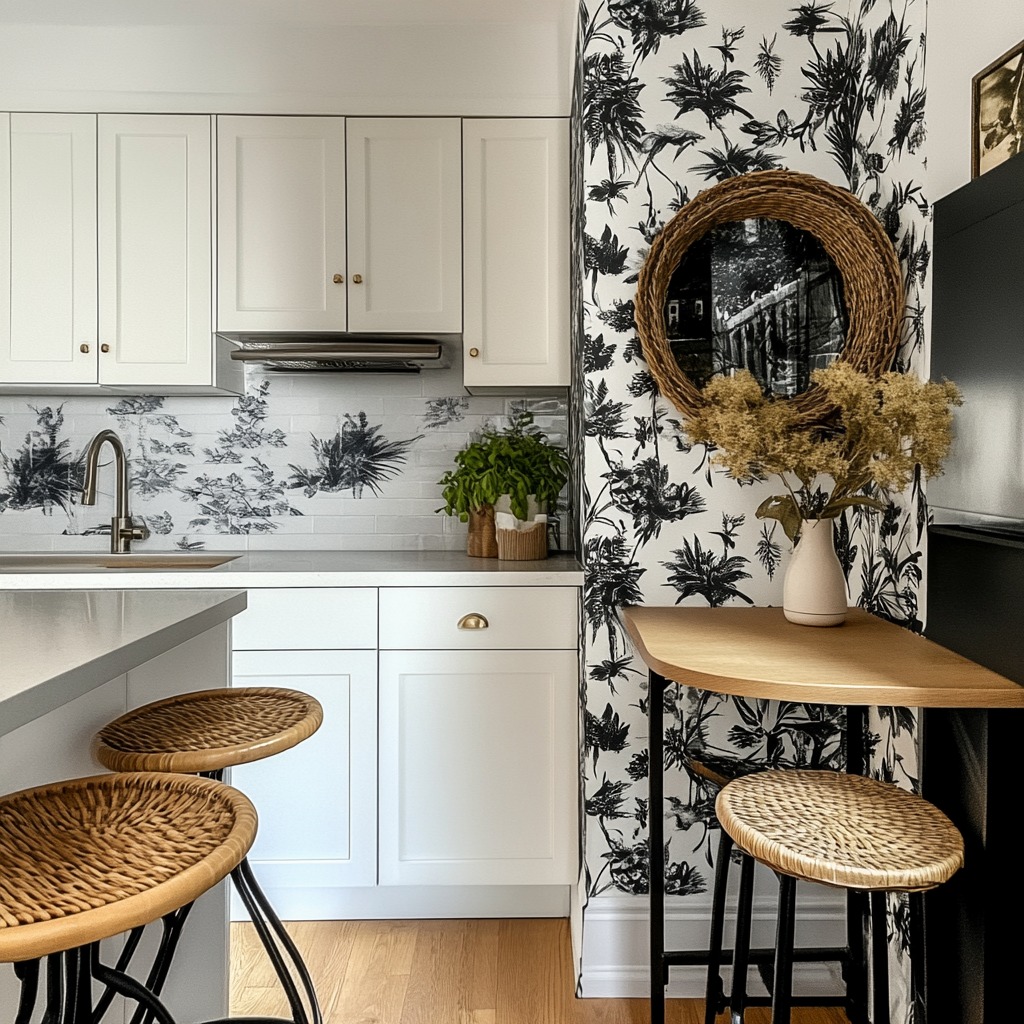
top-left (647, 672), bottom-right (669, 1024)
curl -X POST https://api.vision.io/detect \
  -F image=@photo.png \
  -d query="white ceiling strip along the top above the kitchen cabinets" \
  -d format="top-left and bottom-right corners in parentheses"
top-left (0, 0), bottom-right (577, 26)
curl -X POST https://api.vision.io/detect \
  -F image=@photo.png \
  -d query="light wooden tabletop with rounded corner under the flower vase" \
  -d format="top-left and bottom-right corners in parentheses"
top-left (622, 605), bottom-right (1024, 708)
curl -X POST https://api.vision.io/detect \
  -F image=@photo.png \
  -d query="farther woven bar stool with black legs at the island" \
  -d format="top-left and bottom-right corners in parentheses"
top-left (93, 686), bottom-right (324, 1024)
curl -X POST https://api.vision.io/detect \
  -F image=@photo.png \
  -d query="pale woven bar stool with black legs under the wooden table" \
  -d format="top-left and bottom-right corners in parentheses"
top-left (715, 769), bottom-right (964, 1024)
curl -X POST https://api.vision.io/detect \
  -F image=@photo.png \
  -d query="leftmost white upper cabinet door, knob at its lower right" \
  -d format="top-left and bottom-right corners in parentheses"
top-left (0, 114), bottom-right (98, 384)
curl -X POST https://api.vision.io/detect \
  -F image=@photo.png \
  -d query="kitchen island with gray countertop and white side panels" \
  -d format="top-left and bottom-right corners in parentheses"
top-left (0, 589), bottom-right (247, 1024)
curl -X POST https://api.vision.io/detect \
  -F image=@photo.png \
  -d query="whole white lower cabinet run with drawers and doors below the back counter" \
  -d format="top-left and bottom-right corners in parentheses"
top-left (231, 586), bottom-right (579, 921)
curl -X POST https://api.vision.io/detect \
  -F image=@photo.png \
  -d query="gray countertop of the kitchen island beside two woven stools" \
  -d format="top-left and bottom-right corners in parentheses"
top-left (0, 589), bottom-right (246, 735)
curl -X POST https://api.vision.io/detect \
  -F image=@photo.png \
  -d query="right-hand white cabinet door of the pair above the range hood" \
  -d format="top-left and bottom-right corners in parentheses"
top-left (346, 118), bottom-right (462, 333)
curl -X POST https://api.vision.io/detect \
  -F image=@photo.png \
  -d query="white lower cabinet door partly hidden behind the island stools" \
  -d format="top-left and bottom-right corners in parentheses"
top-left (230, 650), bottom-right (377, 921)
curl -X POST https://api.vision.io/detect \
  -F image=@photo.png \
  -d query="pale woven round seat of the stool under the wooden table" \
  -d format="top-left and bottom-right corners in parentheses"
top-left (715, 770), bottom-right (964, 892)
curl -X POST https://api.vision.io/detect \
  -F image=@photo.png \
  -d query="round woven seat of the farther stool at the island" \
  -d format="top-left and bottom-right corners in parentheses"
top-left (94, 686), bottom-right (324, 772)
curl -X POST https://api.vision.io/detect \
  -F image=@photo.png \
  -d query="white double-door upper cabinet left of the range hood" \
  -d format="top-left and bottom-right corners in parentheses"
top-left (0, 114), bottom-right (233, 393)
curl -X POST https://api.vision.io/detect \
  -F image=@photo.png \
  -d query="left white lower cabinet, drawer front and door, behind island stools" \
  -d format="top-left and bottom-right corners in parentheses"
top-left (230, 587), bottom-right (377, 921)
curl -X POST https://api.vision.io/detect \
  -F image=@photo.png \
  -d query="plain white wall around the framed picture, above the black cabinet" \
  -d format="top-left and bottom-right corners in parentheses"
top-left (926, 0), bottom-right (1024, 202)
